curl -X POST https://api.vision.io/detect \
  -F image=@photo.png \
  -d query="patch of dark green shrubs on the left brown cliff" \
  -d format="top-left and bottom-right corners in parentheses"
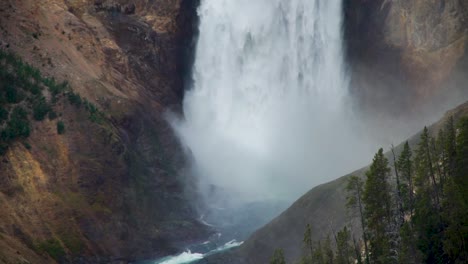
top-left (0, 49), bottom-right (105, 155)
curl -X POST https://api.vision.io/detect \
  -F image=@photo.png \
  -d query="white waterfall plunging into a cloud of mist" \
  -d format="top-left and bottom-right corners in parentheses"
top-left (173, 0), bottom-right (370, 201)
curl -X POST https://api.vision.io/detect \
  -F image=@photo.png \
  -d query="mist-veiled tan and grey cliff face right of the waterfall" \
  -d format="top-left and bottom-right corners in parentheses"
top-left (344, 0), bottom-right (468, 115)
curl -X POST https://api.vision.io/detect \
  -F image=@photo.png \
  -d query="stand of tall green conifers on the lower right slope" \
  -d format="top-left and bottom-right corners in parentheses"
top-left (337, 117), bottom-right (468, 264)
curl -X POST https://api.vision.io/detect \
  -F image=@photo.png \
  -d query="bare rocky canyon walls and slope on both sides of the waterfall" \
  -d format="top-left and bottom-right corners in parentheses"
top-left (0, 0), bottom-right (468, 263)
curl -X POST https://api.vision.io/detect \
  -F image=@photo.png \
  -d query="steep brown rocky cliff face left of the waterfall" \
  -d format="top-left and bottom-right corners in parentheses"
top-left (0, 0), bottom-right (207, 263)
